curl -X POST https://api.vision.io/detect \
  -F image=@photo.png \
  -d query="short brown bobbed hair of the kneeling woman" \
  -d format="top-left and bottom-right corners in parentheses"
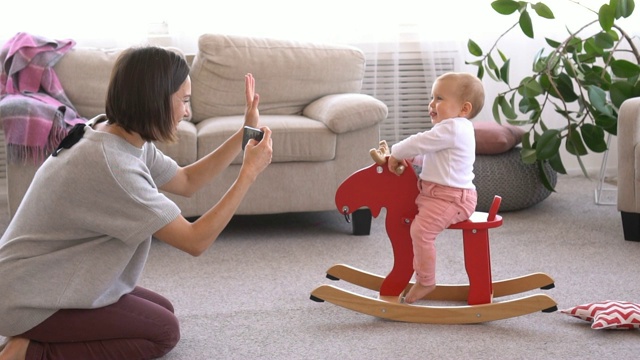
top-left (106, 46), bottom-right (189, 142)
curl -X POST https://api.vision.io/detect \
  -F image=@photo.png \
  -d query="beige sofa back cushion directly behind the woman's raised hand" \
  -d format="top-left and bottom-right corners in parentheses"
top-left (191, 34), bottom-right (365, 122)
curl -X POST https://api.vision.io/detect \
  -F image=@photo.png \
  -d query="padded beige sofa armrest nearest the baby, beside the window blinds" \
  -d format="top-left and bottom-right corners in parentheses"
top-left (302, 94), bottom-right (389, 134)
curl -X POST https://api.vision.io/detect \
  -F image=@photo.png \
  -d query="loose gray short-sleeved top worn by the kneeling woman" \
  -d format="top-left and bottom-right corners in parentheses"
top-left (0, 126), bottom-right (180, 336)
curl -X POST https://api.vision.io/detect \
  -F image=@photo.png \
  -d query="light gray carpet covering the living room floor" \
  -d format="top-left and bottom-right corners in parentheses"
top-left (0, 176), bottom-right (640, 360)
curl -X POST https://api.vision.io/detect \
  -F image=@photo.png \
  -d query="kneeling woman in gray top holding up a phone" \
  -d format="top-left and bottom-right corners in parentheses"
top-left (0, 47), bottom-right (272, 360)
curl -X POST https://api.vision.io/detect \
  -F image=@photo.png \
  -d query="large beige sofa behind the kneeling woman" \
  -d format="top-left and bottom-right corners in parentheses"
top-left (2, 34), bottom-right (387, 217)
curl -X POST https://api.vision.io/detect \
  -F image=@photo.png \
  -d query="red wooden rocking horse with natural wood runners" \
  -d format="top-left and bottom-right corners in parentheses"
top-left (311, 140), bottom-right (557, 324)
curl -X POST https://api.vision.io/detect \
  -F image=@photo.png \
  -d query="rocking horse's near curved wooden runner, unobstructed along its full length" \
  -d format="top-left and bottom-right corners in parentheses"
top-left (311, 285), bottom-right (557, 324)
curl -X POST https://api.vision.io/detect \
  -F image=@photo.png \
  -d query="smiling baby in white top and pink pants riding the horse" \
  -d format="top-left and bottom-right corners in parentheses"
top-left (388, 72), bottom-right (484, 304)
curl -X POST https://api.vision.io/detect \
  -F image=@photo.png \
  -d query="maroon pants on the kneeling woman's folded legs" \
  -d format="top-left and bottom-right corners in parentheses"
top-left (19, 287), bottom-right (180, 360)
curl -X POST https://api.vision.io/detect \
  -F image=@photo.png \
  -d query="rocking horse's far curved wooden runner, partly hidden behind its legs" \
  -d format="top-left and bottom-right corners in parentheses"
top-left (327, 264), bottom-right (555, 301)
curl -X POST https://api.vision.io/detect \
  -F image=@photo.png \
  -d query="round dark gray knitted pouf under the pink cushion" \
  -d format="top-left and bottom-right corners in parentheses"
top-left (473, 147), bottom-right (558, 212)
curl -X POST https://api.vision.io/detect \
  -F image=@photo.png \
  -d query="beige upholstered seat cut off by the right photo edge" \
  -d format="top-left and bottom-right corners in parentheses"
top-left (617, 98), bottom-right (640, 241)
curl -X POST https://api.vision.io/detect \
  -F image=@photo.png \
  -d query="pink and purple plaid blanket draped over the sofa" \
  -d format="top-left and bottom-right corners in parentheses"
top-left (0, 33), bottom-right (86, 161)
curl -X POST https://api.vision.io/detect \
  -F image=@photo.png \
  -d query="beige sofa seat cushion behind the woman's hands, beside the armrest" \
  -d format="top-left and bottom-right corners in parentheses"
top-left (196, 115), bottom-right (337, 164)
